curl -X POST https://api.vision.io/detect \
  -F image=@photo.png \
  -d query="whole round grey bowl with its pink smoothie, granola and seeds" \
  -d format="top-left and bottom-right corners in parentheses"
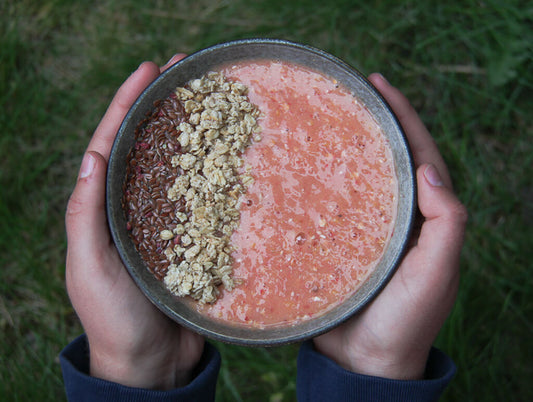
top-left (107, 39), bottom-right (416, 346)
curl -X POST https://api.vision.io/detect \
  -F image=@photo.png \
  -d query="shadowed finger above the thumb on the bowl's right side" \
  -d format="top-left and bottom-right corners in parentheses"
top-left (368, 73), bottom-right (452, 188)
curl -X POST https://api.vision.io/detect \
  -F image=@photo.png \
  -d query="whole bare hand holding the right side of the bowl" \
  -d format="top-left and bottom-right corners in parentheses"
top-left (314, 74), bottom-right (467, 379)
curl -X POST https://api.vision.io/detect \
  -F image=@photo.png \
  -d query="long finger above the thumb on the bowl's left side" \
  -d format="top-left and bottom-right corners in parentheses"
top-left (87, 62), bottom-right (159, 160)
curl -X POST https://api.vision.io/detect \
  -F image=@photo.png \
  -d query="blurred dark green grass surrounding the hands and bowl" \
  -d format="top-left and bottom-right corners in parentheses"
top-left (0, 0), bottom-right (533, 401)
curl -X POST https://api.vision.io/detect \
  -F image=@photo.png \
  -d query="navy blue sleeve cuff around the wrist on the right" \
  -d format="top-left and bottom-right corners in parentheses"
top-left (296, 341), bottom-right (456, 402)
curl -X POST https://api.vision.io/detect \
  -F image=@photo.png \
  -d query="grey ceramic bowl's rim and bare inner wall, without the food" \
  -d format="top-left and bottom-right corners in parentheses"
top-left (107, 39), bottom-right (416, 346)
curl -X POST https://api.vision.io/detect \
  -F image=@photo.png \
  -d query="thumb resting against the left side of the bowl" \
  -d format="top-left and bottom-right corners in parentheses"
top-left (65, 151), bottom-right (110, 252)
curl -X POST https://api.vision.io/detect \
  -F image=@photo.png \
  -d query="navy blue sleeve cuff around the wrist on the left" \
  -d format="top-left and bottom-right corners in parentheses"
top-left (59, 335), bottom-right (220, 402)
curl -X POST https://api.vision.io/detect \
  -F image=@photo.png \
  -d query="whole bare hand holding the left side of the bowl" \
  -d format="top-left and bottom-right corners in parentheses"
top-left (66, 55), bottom-right (204, 389)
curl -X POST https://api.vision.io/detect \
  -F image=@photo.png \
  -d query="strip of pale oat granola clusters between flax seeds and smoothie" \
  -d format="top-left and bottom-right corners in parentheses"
top-left (160, 73), bottom-right (260, 303)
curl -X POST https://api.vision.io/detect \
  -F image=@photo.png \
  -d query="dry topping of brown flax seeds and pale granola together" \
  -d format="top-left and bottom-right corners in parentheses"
top-left (123, 73), bottom-right (260, 303)
